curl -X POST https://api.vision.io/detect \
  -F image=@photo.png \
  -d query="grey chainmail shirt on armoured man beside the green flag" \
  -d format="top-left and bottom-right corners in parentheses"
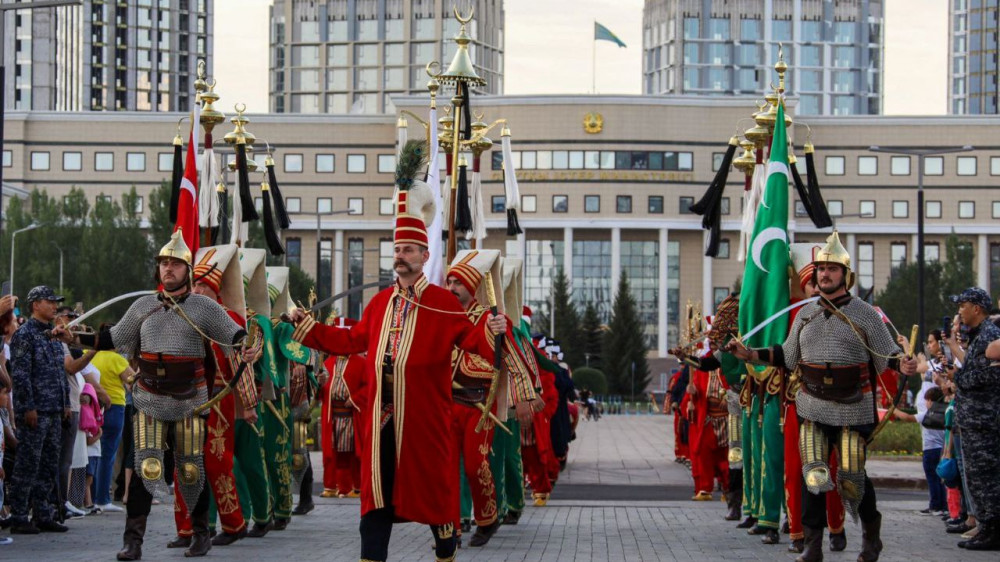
top-left (782, 298), bottom-right (900, 426)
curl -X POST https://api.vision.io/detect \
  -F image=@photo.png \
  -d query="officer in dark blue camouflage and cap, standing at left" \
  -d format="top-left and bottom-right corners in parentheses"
top-left (10, 285), bottom-right (75, 535)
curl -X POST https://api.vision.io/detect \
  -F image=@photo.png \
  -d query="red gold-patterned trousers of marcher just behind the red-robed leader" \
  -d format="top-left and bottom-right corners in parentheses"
top-left (451, 404), bottom-right (497, 527)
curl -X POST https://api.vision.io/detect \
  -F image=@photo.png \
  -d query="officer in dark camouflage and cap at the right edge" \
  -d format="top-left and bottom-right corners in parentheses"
top-left (951, 287), bottom-right (1000, 550)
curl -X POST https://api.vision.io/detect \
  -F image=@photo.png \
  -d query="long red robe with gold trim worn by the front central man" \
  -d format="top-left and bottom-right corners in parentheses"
top-left (295, 276), bottom-right (494, 525)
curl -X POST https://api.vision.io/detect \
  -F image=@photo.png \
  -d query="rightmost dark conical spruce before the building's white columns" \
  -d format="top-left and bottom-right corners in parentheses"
top-left (604, 270), bottom-right (650, 397)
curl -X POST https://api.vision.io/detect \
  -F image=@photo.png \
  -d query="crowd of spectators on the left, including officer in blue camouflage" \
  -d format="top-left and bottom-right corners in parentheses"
top-left (0, 285), bottom-right (132, 544)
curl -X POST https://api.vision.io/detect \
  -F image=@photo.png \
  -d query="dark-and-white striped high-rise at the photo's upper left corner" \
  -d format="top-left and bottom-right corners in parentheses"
top-left (2, 0), bottom-right (214, 111)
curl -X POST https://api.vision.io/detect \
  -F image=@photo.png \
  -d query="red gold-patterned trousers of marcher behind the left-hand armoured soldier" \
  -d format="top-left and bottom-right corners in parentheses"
top-left (174, 393), bottom-right (246, 537)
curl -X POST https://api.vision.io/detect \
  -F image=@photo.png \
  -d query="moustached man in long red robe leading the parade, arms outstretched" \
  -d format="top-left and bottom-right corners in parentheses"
top-left (290, 156), bottom-right (507, 560)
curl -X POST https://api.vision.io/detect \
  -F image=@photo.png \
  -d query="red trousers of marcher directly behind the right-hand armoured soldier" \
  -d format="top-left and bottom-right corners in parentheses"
top-left (785, 402), bottom-right (844, 540)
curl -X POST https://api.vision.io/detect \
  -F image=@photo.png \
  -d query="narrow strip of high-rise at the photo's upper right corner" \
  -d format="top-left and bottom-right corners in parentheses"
top-left (948, 0), bottom-right (1000, 115)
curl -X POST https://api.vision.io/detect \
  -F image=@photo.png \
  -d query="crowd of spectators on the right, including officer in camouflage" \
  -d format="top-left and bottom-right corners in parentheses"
top-left (895, 288), bottom-right (1000, 550)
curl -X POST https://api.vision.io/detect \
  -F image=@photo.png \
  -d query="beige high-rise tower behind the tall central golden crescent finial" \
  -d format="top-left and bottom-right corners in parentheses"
top-left (269, 0), bottom-right (504, 114)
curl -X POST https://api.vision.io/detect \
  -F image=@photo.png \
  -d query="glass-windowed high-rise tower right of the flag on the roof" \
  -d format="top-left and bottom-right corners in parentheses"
top-left (642, 0), bottom-right (883, 115)
